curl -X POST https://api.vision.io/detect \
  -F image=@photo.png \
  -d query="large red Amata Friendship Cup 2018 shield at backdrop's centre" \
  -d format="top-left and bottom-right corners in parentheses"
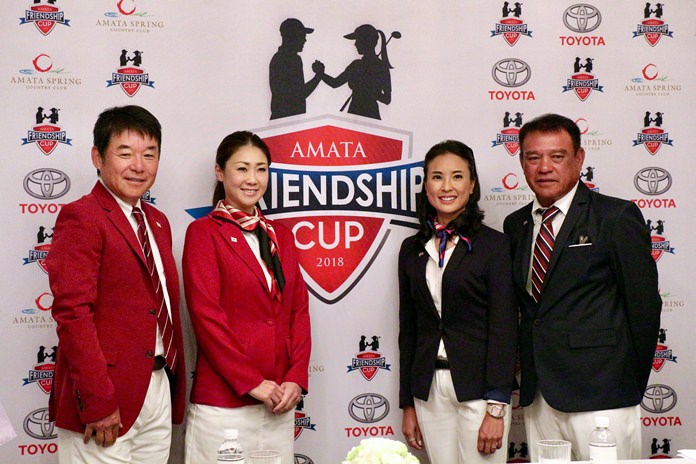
top-left (259, 118), bottom-right (423, 304)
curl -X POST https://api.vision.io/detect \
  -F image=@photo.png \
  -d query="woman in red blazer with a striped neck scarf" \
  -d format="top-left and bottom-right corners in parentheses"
top-left (183, 132), bottom-right (311, 464)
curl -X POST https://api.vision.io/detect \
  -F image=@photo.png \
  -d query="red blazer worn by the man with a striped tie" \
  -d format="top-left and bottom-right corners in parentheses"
top-left (46, 182), bottom-right (186, 435)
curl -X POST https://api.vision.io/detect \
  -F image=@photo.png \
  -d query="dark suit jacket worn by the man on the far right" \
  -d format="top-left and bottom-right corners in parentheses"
top-left (504, 183), bottom-right (662, 412)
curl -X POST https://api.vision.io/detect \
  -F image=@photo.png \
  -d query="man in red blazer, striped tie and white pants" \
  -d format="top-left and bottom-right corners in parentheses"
top-left (47, 106), bottom-right (186, 463)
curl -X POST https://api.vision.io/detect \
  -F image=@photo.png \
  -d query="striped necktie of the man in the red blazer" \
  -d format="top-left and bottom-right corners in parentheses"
top-left (133, 206), bottom-right (177, 371)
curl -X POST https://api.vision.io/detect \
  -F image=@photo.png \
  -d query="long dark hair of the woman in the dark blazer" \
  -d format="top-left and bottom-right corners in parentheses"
top-left (416, 140), bottom-right (484, 244)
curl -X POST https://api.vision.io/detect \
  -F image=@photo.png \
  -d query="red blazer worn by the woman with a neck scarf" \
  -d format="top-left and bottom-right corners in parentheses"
top-left (183, 212), bottom-right (311, 407)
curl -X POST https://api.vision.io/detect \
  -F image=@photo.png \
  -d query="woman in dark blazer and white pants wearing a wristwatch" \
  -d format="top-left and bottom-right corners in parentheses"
top-left (399, 140), bottom-right (518, 464)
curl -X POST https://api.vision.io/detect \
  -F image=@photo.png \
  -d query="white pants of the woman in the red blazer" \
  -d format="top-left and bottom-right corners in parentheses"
top-left (184, 403), bottom-right (295, 464)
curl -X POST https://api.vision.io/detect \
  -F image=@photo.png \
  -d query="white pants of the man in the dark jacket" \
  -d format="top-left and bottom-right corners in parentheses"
top-left (524, 392), bottom-right (641, 462)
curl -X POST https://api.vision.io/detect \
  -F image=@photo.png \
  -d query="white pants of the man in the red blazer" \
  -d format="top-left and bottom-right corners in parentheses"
top-left (58, 369), bottom-right (172, 464)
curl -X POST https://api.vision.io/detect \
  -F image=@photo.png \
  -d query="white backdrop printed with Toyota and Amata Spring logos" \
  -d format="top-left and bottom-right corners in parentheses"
top-left (0, 0), bottom-right (696, 464)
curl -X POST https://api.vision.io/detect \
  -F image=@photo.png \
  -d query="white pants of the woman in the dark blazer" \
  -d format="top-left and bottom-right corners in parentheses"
top-left (415, 369), bottom-right (510, 464)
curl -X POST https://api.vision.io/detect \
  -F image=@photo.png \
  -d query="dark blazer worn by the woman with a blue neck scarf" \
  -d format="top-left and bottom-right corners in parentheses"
top-left (399, 226), bottom-right (518, 408)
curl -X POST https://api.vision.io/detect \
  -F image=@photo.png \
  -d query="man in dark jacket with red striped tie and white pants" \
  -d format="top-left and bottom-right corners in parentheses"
top-left (504, 114), bottom-right (662, 461)
